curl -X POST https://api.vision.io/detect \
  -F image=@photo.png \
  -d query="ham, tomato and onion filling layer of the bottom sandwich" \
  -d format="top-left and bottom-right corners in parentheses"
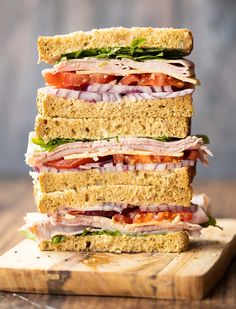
top-left (21, 195), bottom-right (215, 241)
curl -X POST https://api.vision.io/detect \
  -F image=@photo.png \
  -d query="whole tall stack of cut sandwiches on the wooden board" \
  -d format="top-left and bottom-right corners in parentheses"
top-left (22, 27), bottom-right (215, 252)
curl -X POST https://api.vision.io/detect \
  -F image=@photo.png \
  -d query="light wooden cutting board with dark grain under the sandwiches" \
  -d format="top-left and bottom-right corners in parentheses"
top-left (0, 219), bottom-right (236, 299)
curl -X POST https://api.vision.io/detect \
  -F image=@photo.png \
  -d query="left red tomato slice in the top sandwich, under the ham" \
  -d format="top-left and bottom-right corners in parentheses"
top-left (44, 72), bottom-right (116, 88)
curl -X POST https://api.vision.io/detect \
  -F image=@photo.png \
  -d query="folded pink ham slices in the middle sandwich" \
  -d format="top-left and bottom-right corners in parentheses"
top-left (26, 133), bottom-right (212, 167)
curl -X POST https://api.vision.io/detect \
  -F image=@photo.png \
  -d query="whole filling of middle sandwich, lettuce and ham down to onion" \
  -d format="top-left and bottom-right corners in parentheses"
top-left (26, 134), bottom-right (212, 171)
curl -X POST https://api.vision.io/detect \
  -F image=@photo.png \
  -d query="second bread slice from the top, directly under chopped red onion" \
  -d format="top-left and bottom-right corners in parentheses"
top-left (37, 88), bottom-right (193, 119)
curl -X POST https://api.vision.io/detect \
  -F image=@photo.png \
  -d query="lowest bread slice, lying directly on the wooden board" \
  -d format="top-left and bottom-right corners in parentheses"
top-left (39, 231), bottom-right (189, 253)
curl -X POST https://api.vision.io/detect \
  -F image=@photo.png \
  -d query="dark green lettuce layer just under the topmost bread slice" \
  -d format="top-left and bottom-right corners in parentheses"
top-left (59, 38), bottom-right (184, 62)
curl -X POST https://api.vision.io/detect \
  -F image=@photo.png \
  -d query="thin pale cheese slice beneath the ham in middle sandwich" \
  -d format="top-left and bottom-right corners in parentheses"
top-left (64, 149), bottom-right (184, 160)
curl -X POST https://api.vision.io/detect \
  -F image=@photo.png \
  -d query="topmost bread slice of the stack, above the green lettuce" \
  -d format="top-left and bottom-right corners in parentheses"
top-left (38, 27), bottom-right (193, 64)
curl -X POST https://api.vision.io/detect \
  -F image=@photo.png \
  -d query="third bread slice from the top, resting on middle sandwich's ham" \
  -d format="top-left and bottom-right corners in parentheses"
top-left (35, 114), bottom-right (191, 142)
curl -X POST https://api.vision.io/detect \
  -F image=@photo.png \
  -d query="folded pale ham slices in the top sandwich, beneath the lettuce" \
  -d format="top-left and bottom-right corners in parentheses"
top-left (42, 58), bottom-right (199, 85)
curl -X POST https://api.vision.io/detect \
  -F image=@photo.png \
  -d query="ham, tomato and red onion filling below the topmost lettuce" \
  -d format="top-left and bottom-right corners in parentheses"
top-left (42, 58), bottom-right (199, 95)
